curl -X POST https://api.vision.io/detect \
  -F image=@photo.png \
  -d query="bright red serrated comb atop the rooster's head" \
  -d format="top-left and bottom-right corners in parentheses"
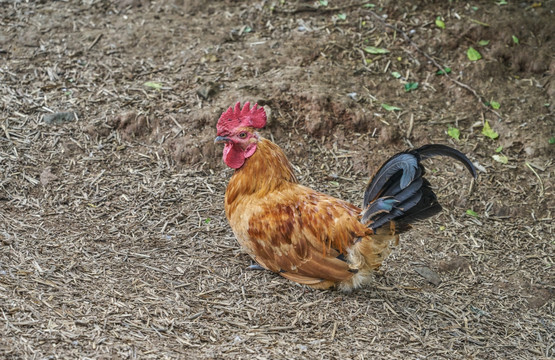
top-left (217, 101), bottom-right (266, 134)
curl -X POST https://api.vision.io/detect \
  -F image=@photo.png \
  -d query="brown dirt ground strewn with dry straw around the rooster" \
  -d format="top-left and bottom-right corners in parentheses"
top-left (0, 0), bottom-right (555, 359)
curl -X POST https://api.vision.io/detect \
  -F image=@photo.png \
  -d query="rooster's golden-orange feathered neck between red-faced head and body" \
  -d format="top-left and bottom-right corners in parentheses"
top-left (225, 137), bottom-right (298, 211)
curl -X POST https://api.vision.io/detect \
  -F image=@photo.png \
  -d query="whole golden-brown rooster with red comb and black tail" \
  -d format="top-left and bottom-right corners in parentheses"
top-left (215, 102), bottom-right (476, 291)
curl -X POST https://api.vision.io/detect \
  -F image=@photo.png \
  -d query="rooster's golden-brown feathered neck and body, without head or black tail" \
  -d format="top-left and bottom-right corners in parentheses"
top-left (225, 138), bottom-right (398, 290)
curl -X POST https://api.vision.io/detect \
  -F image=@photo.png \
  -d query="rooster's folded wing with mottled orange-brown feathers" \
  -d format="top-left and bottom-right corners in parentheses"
top-left (237, 184), bottom-right (372, 285)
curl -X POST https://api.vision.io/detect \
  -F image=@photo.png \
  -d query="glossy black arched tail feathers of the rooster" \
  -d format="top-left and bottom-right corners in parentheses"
top-left (361, 144), bottom-right (476, 230)
